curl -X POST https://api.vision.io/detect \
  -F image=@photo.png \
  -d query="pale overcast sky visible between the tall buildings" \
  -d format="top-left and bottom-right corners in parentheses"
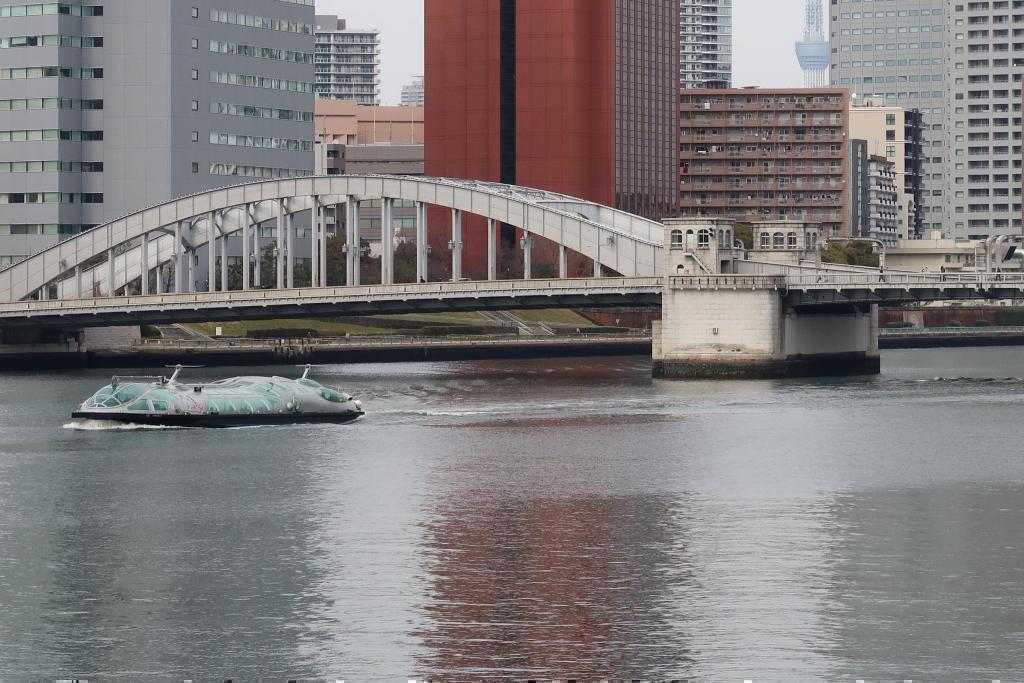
top-left (316, 0), bottom-right (804, 104)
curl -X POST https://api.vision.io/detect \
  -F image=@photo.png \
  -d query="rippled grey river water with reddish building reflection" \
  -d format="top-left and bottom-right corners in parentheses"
top-left (0, 349), bottom-right (1024, 681)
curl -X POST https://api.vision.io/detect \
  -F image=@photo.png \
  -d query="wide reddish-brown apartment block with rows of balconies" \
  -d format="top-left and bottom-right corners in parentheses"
top-left (679, 88), bottom-right (850, 237)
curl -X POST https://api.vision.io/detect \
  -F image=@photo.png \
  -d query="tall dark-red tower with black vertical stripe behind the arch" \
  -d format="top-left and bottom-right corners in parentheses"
top-left (425, 0), bottom-right (679, 279)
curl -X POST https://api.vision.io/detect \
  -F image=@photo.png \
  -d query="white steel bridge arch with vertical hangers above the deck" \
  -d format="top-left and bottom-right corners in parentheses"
top-left (0, 175), bottom-right (664, 301)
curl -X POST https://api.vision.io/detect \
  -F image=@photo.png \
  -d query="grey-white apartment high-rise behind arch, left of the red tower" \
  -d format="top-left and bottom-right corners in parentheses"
top-left (311, 15), bottom-right (381, 105)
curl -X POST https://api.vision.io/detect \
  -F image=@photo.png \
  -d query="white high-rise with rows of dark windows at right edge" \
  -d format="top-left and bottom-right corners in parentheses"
top-left (946, 0), bottom-right (1024, 239)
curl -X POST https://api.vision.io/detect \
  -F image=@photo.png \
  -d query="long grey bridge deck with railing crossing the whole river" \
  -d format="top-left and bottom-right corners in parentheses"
top-left (0, 272), bottom-right (1024, 329)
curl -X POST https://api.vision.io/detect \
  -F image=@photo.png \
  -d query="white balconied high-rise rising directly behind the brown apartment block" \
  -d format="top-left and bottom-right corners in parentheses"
top-left (679, 0), bottom-right (732, 88)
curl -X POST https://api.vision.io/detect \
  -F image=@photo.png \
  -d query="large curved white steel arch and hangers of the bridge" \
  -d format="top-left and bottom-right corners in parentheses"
top-left (0, 175), bottom-right (664, 302)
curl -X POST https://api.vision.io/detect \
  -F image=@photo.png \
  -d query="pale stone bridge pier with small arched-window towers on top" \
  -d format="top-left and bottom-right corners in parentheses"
top-left (653, 219), bottom-right (881, 379)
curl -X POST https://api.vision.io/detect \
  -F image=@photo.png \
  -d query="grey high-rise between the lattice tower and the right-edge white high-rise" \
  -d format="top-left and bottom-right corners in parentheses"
top-left (828, 0), bottom-right (946, 233)
